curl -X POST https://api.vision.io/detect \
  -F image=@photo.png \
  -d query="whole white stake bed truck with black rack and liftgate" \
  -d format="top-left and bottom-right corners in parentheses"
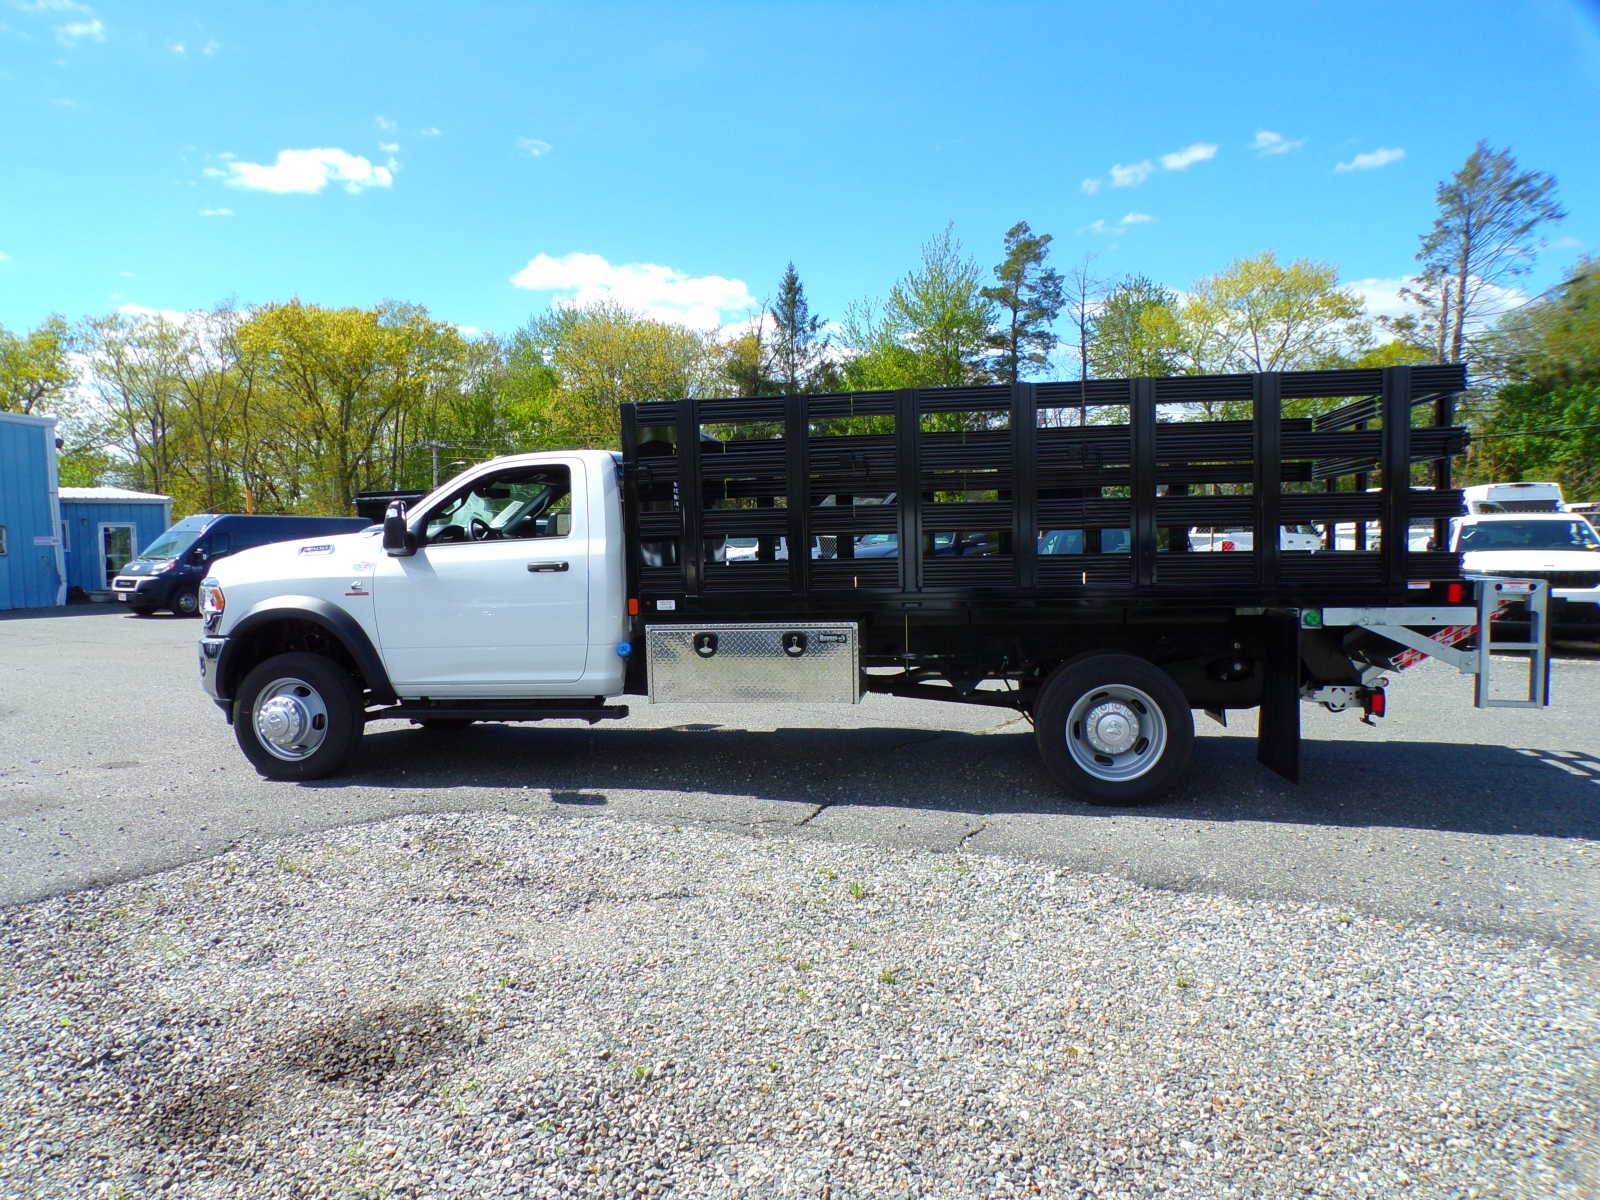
top-left (200, 366), bottom-right (1547, 803)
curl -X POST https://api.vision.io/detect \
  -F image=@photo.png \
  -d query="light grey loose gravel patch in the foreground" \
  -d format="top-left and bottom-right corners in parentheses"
top-left (0, 814), bottom-right (1600, 1200)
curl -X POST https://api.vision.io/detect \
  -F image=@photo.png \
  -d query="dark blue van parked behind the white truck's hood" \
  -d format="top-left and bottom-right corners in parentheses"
top-left (110, 512), bottom-right (370, 616)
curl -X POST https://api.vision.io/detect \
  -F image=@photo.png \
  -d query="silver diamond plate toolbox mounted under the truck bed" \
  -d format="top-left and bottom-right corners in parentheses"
top-left (645, 622), bottom-right (861, 704)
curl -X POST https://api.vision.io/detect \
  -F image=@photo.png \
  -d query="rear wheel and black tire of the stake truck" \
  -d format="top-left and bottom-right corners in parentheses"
top-left (1034, 654), bottom-right (1195, 805)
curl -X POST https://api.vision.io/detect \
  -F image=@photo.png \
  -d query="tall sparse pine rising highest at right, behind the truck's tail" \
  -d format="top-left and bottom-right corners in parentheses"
top-left (1410, 142), bottom-right (1566, 363)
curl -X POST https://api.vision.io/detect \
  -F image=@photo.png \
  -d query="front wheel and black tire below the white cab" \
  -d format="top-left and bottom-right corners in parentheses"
top-left (234, 653), bottom-right (366, 782)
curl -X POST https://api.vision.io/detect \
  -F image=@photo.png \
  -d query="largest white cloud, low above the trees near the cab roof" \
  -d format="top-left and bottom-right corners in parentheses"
top-left (510, 253), bottom-right (757, 330)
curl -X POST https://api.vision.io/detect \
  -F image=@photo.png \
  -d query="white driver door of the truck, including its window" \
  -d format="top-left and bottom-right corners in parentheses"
top-left (373, 459), bottom-right (589, 699)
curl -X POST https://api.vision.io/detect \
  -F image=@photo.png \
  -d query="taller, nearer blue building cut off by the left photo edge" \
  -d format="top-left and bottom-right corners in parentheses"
top-left (0, 413), bottom-right (67, 608)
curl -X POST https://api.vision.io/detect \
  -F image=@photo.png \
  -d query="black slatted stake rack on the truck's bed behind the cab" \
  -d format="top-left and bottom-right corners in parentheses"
top-left (622, 366), bottom-right (1466, 613)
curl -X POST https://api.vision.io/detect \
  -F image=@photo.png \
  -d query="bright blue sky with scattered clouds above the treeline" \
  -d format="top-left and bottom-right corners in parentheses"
top-left (0, 0), bottom-right (1600, 352)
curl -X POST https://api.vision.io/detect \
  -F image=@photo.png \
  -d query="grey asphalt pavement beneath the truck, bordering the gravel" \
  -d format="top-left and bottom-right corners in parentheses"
top-left (0, 605), bottom-right (1600, 950)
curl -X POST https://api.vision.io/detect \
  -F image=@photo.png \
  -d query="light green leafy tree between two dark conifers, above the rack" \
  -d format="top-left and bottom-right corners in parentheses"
top-left (843, 224), bottom-right (995, 389)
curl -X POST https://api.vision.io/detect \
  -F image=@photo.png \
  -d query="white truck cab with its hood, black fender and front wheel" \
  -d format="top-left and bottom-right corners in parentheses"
top-left (200, 451), bottom-right (627, 779)
